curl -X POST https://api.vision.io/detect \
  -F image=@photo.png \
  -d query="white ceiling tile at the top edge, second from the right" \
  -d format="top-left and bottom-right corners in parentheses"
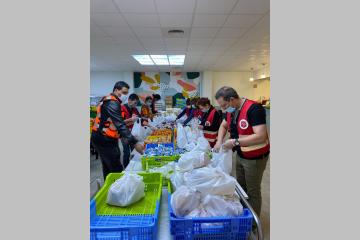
top-left (196, 0), bottom-right (237, 14)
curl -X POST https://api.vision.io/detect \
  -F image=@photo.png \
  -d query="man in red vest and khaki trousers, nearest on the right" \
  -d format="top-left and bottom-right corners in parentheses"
top-left (214, 87), bottom-right (270, 216)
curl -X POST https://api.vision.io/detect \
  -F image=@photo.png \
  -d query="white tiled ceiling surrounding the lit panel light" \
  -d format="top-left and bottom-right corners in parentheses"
top-left (90, 0), bottom-right (270, 71)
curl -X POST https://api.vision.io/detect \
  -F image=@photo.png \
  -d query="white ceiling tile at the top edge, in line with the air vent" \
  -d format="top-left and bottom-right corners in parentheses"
top-left (155, 0), bottom-right (195, 14)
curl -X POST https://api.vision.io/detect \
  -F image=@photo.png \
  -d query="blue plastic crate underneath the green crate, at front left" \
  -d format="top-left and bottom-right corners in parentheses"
top-left (90, 200), bottom-right (160, 240)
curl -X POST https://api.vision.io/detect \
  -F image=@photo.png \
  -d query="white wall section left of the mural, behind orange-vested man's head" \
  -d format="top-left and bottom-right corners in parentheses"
top-left (90, 71), bottom-right (134, 96)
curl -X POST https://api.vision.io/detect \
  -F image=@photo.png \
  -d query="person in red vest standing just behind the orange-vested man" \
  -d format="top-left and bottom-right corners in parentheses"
top-left (121, 93), bottom-right (140, 168)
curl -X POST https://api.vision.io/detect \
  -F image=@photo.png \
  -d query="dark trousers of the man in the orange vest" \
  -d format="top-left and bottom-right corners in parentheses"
top-left (91, 131), bottom-right (123, 180)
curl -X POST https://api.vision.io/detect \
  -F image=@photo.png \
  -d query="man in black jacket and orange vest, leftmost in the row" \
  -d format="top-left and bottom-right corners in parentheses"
top-left (91, 81), bottom-right (144, 179)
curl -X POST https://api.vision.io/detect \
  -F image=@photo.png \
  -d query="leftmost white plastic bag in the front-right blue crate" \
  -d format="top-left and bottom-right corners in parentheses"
top-left (170, 186), bottom-right (200, 217)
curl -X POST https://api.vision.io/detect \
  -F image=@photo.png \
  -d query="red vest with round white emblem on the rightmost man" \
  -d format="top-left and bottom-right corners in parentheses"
top-left (226, 99), bottom-right (270, 158)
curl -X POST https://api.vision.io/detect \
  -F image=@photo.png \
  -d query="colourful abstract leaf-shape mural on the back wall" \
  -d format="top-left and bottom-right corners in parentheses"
top-left (134, 72), bottom-right (201, 106)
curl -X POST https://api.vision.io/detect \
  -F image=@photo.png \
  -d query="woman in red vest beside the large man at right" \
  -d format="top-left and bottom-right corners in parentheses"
top-left (197, 98), bottom-right (222, 148)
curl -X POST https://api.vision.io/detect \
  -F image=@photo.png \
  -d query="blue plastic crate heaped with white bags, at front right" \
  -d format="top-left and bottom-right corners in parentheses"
top-left (168, 190), bottom-right (253, 240)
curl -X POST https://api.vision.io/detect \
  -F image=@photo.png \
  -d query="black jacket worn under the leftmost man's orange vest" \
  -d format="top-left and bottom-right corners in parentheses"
top-left (100, 94), bottom-right (138, 145)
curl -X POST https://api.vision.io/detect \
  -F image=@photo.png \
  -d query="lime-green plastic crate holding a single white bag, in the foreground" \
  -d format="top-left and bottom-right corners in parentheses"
top-left (94, 173), bottom-right (163, 216)
